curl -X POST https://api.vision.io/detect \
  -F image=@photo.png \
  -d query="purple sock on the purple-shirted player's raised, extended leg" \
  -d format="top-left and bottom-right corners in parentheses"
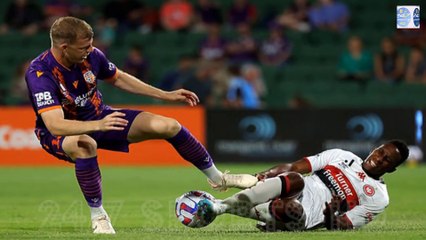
top-left (167, 126), bottom-right (213, 170)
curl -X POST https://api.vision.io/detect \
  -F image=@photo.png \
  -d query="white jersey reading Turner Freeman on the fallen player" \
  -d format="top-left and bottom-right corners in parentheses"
top-left (302, 149), bottom-right (389, 228)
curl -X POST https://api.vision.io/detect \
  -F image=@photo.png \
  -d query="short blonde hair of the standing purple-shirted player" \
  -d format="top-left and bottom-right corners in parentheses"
top-left (50, 17), bottom-right (93, 45)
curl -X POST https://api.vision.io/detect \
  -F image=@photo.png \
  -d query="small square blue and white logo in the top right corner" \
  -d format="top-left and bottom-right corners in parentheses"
top-left (396, 5), bottom-right (420, 29)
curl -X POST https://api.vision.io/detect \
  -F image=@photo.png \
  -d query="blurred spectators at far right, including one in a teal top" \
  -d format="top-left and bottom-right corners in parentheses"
top-left (338, 29), bottom-right (426, 85)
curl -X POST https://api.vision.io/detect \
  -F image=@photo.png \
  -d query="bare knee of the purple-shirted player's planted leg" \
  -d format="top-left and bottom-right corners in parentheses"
top-left (63, 135), bottom-right (97, 159)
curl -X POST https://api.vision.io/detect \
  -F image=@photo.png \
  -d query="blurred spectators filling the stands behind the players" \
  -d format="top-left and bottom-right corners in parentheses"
top-left (0, 0), bottom-right (426, 109)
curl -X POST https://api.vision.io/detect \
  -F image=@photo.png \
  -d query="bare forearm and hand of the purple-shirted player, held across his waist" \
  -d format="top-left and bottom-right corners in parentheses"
top-left (41, 107), bottom-right (128, 136)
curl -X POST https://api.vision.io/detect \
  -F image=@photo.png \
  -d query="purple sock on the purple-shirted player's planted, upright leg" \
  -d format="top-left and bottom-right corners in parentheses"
top-left (75, 157), bottom-right (102, 207)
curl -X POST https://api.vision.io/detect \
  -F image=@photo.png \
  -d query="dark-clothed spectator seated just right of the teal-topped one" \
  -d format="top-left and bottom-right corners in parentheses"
top-left (374, 38), bottom-right (405, 83)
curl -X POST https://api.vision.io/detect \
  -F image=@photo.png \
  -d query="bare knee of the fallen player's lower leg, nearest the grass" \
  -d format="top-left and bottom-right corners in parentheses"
top-left (269, 198), bottom-right (304, 223)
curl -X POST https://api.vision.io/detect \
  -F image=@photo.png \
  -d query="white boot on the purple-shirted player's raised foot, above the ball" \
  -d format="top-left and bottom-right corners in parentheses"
top-left (207, 171), bottom-right (259, 192)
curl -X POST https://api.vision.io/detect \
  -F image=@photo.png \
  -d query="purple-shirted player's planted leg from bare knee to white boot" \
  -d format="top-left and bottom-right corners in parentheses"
top-left (62, 135), bottom-right (115, 234)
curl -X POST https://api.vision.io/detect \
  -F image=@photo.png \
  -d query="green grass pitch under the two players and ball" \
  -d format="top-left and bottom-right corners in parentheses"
top-left (0, 165), bottom-right (426, 240)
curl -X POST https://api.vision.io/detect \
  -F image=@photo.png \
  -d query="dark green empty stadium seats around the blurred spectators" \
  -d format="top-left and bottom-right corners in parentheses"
top-left (0, 0), bottom-right (426, 107)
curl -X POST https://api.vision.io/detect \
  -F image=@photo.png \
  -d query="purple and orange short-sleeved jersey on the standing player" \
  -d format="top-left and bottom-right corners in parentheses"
top-left (25, 48), bottom-right (117, 129)
